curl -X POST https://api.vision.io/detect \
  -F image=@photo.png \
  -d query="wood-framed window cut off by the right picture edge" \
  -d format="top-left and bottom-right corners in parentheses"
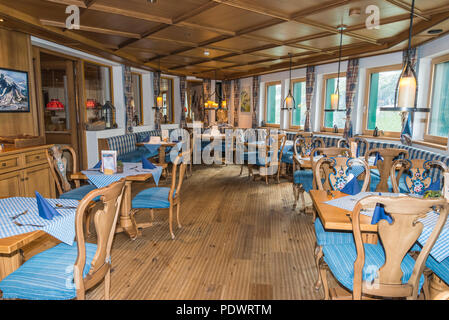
top-left (424, 56), bottom-right (449, 144)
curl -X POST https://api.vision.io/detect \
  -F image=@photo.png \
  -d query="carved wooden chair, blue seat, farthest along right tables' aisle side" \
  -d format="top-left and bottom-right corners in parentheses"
top-left (293, 132), bottom-right (324, 211)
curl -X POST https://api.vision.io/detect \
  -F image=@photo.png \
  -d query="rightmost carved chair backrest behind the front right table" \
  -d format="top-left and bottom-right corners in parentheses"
top-left (390, 159), bottom-right (448, 195)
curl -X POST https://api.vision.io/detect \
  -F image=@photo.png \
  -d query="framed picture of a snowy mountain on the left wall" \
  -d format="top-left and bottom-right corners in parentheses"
top-left (0, 68), bottom-right (30, 112)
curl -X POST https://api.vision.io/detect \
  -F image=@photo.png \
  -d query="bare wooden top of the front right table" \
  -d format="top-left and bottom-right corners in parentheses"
top-left (310, 190), bottom-right (377, 243)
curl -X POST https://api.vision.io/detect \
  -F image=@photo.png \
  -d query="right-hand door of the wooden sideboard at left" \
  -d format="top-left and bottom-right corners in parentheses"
top-left (24, 164), bottom-right (55, 198)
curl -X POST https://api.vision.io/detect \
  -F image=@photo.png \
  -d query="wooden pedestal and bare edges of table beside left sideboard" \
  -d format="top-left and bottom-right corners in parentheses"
top-left (71, 163), bottom-right (167, 240)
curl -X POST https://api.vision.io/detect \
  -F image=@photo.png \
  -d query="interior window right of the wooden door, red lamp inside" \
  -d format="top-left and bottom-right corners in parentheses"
top-left (83, 61), bottom-right (115, 123)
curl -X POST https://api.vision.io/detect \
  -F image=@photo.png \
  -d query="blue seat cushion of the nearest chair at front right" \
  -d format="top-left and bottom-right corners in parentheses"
top-left (323, 243), bottom-right (424, 291)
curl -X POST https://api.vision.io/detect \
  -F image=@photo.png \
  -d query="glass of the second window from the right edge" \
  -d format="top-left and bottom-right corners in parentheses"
top-left (367, 70), bottom-right (402, 132)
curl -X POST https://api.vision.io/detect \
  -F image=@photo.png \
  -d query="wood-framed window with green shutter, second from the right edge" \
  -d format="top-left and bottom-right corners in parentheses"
top-left (364, 65), bottom-right (402, 137)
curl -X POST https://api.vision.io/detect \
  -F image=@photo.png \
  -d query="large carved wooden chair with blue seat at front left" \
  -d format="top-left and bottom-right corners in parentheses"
top-left (0, 179), bottom-right (125, 300)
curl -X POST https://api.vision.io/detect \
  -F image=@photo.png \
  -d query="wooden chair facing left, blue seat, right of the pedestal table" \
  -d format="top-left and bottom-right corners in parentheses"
top-left (131, 152), bottom-right (190, 239)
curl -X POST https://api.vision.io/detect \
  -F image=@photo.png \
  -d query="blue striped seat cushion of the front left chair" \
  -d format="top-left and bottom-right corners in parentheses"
top-left (0, 242), bottom-right (97, 300)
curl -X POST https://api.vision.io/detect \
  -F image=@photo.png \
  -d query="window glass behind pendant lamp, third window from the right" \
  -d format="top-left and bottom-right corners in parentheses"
top-left (324, 77), bottom-right (346, 129)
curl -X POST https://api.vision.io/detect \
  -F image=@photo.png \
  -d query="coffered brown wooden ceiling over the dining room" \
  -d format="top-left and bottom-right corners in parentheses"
top-left (0, 0), bottom-right (449, 79)
